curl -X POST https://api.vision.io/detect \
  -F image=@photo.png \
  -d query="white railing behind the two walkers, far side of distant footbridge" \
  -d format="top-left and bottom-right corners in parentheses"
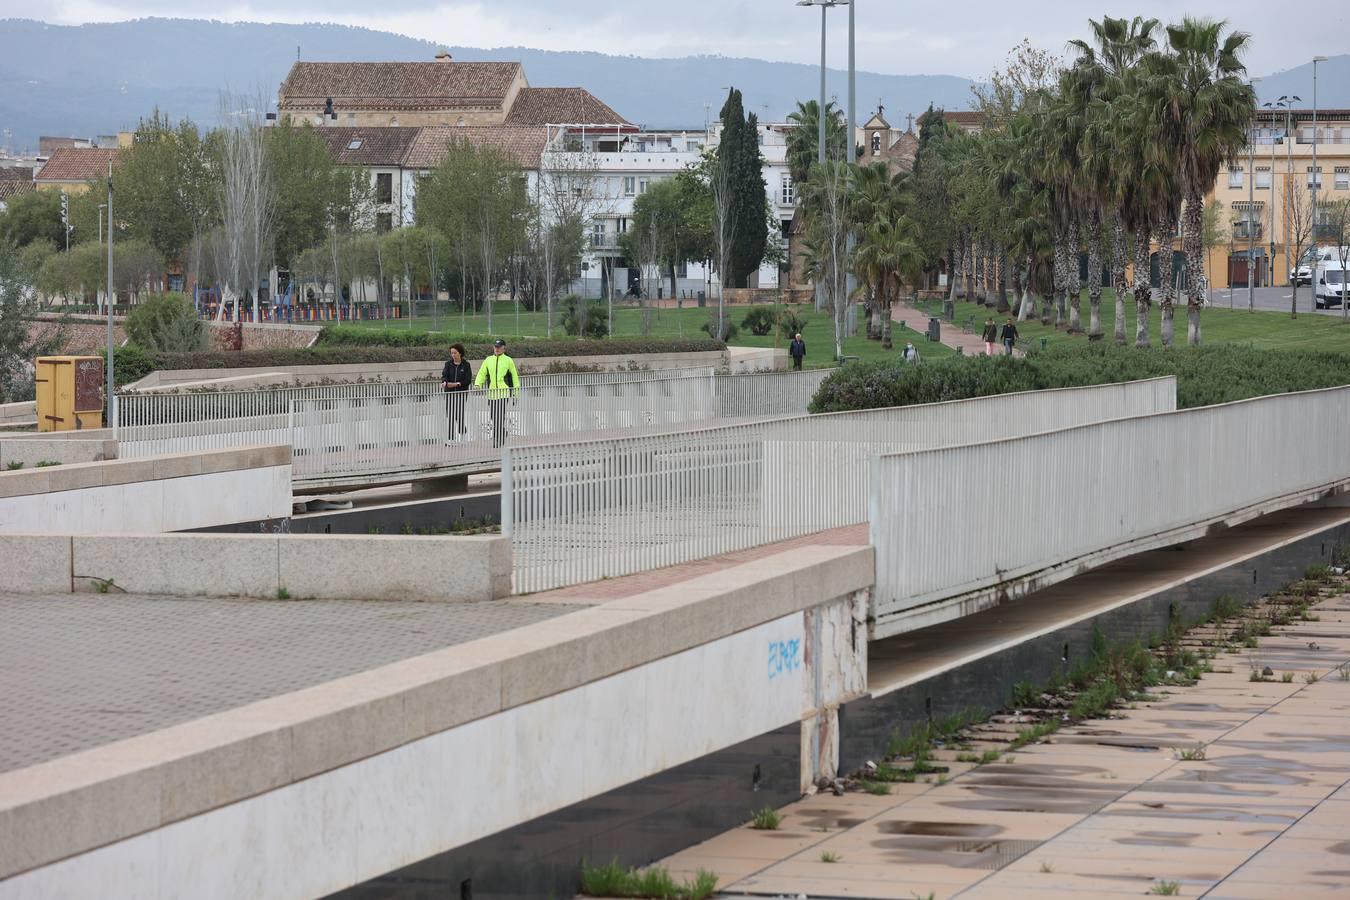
top-left (117, 366), bottom-right (716, 457)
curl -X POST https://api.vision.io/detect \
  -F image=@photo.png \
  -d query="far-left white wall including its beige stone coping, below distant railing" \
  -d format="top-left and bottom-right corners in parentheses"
top-left (0, 441), bottom-right (290, 534)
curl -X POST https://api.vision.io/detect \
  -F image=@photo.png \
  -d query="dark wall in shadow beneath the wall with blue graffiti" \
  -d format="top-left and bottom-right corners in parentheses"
top-left (331, 723), bottom-right (802, 900)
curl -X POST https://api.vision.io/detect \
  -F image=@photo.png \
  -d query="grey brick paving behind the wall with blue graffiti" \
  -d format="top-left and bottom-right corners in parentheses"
top-left (0, 594), bottom-right (576, 772)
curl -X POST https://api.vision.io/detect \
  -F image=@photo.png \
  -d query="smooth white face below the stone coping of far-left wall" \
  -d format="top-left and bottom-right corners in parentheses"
top-left (0, 466), bottom-right (290, 534)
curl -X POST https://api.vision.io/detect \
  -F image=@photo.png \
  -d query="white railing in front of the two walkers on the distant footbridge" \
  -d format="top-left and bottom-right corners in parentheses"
top-left (289, 372), bottom-right (821, 482)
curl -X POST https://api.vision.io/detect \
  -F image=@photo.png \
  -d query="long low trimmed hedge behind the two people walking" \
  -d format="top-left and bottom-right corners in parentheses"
top-left (154, 337), bottom-right (726, 370)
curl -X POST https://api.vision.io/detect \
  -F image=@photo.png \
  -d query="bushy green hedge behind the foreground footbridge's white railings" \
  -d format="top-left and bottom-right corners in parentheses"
top-left (810, 344), bottom-right (1350, 413)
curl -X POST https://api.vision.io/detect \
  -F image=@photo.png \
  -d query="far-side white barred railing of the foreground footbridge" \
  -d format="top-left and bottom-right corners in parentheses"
top-left (502, 378), bottom-right (1176, 592)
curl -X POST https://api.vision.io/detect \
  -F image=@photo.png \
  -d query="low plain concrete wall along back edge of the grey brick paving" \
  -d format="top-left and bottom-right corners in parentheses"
top-left (0, 534), bottom-right (510, 602)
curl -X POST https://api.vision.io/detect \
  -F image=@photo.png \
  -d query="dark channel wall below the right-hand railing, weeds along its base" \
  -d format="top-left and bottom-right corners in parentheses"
top-left (840, 525), bottom-right (1350, 772)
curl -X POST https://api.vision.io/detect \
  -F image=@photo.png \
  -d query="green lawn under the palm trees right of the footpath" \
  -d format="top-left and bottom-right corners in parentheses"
top-left (922, 289), bottom-right (1350, 352)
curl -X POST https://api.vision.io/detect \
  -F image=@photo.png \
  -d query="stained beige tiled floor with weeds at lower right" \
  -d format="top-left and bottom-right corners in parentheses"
top-left (664, 598), bottom-right (1350, 900)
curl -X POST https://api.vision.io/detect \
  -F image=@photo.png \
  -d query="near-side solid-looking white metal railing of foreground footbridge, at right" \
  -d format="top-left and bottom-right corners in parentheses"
top-left (868, 387), bottom-right (1350, 636)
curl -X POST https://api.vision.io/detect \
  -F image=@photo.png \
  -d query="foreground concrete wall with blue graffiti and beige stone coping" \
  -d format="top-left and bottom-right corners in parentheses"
top-left (0, 546), bottom-right (872, 900)
